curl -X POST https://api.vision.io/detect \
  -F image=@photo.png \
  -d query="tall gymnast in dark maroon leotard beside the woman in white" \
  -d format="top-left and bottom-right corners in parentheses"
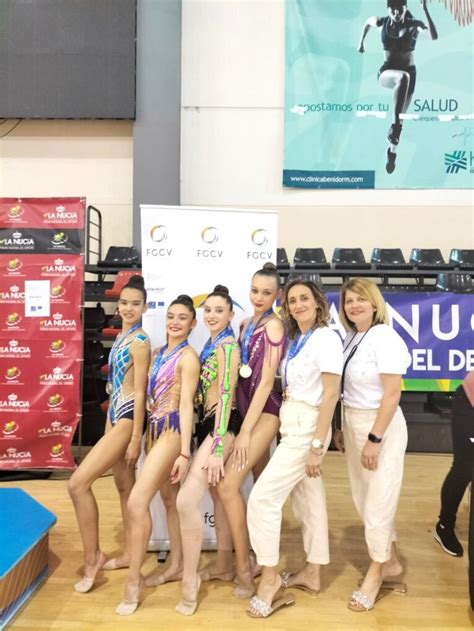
top-left (218, 263), bottom-right (286, 598)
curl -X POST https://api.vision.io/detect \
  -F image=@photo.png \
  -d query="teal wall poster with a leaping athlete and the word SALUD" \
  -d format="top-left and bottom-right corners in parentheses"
top-left (283, 0), bottom-right (474, 189)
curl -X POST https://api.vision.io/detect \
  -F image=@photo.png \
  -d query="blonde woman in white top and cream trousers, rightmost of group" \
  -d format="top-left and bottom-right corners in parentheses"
top-left (334, 278), bottom-right (410, 611)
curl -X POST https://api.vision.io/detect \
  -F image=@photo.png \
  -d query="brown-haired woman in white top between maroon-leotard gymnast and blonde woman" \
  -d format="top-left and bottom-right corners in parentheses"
top-left (247, 280), bottom-right (342, 618)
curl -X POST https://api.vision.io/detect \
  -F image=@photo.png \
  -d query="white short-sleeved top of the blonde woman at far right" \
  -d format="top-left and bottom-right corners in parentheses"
top-left (344, 324), bottom-right (411, 410)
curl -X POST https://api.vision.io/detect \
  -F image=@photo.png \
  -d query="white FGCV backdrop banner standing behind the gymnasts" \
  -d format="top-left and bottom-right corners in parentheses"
top-left (141, 205), bottom-right (278, 550)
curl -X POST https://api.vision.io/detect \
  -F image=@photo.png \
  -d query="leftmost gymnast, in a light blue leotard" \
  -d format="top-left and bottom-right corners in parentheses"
top-left (68, 276), bottom-right (150, 593)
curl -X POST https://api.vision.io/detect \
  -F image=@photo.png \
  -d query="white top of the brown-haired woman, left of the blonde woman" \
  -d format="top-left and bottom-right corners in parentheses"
top-left (281, 326), bottom-right (342, 406)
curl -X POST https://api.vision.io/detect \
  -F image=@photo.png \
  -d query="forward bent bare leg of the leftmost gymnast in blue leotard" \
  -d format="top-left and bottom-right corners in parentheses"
top-left (68, 419), bottom-right (132, 592)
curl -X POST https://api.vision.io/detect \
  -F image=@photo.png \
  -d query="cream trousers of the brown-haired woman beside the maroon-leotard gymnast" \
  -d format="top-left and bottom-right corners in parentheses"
top-left (247, 399), bottom-right (331, 567)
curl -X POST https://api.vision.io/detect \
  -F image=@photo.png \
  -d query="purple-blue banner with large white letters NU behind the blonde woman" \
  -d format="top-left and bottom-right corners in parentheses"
top-left (327, 292), bottom-right (474, 391)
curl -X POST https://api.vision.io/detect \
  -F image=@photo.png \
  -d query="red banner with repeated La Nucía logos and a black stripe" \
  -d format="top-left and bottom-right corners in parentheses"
top-left (0, 198), bottom-right (85, 470)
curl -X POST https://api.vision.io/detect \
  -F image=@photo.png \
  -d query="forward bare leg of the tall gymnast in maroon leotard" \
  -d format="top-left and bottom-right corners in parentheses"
top-left (218, 414), bottom-right (279, 598)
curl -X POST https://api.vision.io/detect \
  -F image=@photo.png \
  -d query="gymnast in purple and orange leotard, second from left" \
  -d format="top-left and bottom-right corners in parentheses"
top-left (116, 295), bottom-right (200, 616)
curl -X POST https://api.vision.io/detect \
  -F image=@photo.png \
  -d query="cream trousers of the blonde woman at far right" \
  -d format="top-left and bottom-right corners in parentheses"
top-left (344, 406), bottom-right (408, 563)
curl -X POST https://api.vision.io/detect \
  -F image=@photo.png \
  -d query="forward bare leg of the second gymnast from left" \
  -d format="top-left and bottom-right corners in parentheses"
top-left (116, 432), bottom-right (181, 615)
